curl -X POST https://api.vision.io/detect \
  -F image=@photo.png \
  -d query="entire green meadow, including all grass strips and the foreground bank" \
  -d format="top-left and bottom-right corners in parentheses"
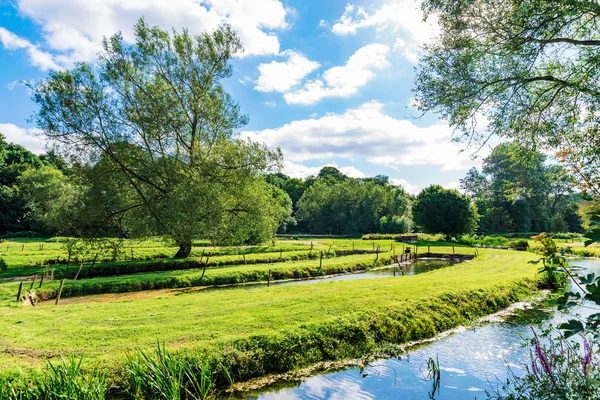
top-left (0, 238), bottom-right (539, 397)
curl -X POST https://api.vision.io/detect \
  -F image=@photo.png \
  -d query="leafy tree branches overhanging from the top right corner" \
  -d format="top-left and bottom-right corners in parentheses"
top-left (416, 0), bottom-right (600, 197)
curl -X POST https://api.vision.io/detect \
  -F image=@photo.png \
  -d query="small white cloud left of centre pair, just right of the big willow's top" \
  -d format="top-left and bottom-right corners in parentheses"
top-left (254, 50), bottom-right (320, 93)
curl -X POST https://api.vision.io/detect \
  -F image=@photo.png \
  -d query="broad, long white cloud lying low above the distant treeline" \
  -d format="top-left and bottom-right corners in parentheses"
top-left (241, 101), bottom-right (483, 171)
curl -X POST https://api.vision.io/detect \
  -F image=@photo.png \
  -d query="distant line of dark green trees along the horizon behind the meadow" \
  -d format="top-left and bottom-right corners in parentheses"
top-left (0, 136), bottom-right (584, 241)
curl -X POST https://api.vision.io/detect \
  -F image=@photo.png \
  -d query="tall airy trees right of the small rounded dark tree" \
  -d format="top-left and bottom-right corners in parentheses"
top-left (460, 142), bottom-right (582, 234)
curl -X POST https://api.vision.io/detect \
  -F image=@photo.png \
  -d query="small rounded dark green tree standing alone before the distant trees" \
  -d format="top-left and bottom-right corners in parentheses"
top-left (413, 185), bottom-right (479, 240)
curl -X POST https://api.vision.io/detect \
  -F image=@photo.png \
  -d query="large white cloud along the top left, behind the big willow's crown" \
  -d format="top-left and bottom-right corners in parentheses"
top-left (3, 0), bottom-right (288, 70)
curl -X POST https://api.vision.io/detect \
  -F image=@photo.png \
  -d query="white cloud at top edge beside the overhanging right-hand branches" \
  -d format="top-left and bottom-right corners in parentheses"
top-left (331, 0), bottom-right (439, 63)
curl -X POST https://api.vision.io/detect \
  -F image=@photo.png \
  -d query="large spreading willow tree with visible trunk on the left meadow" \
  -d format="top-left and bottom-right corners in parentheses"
top-left (32, 19), bottom-right (288, 257)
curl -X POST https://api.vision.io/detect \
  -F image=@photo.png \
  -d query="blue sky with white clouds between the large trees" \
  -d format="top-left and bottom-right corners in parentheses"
top-left (0, 0), bottom-right (486, 193)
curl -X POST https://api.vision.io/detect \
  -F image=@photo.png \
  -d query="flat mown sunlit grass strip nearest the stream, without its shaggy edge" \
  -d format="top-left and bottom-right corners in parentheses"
top-left (0, 250), bottom-right (536, 368)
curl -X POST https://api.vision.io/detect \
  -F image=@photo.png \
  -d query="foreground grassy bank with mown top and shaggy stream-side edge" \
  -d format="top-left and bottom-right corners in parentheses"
top-left (0, 249), bottom-right (537, 392)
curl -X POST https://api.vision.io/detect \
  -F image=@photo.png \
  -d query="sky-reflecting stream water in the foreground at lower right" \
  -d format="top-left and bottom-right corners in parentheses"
top-left (247, 259), bottom-right (600, 400)
